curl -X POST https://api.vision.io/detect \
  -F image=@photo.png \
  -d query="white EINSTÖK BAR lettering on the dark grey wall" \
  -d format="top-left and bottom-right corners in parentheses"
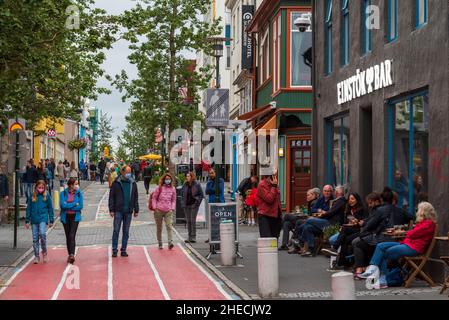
top-left (337, 60), bottom-right (393, 105)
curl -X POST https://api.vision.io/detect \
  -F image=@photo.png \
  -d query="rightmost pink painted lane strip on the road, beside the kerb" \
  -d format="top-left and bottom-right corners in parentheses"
top-left (147, 246), bottom-right (226, 300)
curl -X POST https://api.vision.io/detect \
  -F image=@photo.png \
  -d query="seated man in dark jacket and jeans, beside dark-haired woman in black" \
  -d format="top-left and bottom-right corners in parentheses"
top-left (292, 186), bottom-right (346, 257)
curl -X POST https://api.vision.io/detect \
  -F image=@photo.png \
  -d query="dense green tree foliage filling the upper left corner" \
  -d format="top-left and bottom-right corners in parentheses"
top-left (0, 0), bottom-right (118, 127)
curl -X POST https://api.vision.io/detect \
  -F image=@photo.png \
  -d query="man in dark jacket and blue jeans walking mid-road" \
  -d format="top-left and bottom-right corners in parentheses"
top-left (109, 166), bottom-right (139, 258)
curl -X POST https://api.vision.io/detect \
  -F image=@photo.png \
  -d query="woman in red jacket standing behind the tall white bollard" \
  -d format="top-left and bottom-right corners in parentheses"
top-left (256, 175), bottom-right (282, 238)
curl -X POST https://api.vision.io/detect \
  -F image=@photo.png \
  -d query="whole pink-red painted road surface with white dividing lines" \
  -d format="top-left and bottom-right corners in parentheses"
top-left (0, 246), bottom-right (230, 300)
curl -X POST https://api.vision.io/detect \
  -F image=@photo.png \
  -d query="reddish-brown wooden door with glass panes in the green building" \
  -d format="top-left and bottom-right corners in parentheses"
top-left (290, 138), bottom-right (312, 211)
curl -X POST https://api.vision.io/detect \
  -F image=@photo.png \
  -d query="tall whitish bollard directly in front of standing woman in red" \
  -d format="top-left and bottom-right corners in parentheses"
top-left (257, 238), bottom-right (279, 298)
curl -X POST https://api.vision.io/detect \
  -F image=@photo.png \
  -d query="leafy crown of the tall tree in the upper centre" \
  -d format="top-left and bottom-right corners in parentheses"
top-left (114, 0), bottom-right (221, 170)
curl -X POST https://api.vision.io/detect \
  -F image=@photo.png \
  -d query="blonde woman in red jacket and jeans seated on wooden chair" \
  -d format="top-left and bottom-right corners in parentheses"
top-left (360, 202), bottom-right (437, 288)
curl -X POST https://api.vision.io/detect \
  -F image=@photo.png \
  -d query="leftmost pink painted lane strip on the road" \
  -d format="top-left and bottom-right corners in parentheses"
top-left (0, 248), bottom-right (67, 300)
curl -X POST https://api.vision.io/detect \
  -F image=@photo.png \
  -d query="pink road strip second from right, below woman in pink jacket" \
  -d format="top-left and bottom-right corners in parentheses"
top-left (112, 246), bottom-right (164, 300)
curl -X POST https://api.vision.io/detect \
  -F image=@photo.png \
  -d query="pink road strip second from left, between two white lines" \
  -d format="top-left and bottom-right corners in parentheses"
top-left (58, 247), bottom-right (108, 300)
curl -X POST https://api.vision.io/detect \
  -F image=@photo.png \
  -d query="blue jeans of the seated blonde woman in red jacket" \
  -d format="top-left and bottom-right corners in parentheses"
top-left (370, 242), bottom-right (418, 274)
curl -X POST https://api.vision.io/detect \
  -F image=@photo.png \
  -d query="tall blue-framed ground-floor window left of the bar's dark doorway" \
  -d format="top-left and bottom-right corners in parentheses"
top-left (327, 114), bottom-right (351, 190)
